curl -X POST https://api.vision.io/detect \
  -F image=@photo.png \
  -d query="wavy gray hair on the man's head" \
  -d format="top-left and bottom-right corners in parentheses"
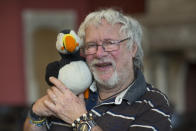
top-left (78, 9), bottom-right (143, 69)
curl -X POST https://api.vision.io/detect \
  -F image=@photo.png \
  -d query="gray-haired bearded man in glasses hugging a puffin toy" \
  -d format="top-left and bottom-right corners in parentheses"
top-left (24, 9), bottom-right (172, 131)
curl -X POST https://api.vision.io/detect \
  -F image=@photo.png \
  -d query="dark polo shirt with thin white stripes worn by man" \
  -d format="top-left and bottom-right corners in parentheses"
top-left (46, 70), bottom-right (172, 131)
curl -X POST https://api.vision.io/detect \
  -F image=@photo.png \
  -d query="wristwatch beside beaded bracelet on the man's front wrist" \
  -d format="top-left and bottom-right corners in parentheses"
top-left (77, 120), bottom-right (97, 131)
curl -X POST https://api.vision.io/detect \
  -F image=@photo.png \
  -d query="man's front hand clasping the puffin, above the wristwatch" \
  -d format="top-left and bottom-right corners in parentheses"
top-left (44, 77), bottom-right (87, 124)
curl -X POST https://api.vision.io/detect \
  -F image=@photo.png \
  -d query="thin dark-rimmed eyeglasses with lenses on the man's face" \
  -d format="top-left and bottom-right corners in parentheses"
top-left (84, 37), bottom-right (131, 55)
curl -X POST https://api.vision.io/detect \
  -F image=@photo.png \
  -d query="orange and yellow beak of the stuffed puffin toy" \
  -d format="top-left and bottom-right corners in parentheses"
top-left (63, 34), bottom-right (79, 52)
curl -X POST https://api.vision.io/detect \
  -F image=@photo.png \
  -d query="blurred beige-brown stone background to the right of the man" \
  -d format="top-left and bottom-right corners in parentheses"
top-left (136, 0), bottom-right (196, 131)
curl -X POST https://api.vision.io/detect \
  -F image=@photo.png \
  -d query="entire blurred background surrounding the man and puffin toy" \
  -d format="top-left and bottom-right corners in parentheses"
top-left (0, 0), bottom-right (196, 131)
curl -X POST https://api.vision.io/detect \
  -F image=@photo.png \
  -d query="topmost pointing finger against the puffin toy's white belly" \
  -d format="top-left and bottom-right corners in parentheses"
top-left (49, 77), bottom-right (68, 92)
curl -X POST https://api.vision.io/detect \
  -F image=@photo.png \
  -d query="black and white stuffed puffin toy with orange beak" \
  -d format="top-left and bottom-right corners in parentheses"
top-left (45, 29), bottom-right (92, 98)
